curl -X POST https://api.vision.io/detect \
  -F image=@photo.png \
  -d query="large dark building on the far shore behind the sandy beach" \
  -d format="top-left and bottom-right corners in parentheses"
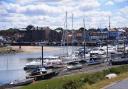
top-left (15, 27), bottom-right (61, 42)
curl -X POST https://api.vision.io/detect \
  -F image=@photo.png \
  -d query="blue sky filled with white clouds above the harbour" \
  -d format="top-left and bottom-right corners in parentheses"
top-left (0, 0), bottom-right (128, 30)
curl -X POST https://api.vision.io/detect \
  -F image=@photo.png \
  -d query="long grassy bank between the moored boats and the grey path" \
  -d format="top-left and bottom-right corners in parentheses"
top-left (21, 65), bottom-right (128, 89)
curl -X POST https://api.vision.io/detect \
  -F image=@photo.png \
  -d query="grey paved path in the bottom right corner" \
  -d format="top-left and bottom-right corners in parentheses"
top-left (104, 79), bottom-right (128, 89)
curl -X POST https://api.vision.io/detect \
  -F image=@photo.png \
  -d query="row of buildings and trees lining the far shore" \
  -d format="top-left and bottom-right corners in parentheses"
top-left (0, 25), bottom-right (128, 45)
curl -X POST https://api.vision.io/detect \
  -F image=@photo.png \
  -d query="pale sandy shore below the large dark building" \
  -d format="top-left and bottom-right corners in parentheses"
top-left (11, 46), bottom-right (61, 53)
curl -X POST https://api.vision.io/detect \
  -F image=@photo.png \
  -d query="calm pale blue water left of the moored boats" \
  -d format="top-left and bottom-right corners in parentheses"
top-left (0, 47), bottom-right (78, 84)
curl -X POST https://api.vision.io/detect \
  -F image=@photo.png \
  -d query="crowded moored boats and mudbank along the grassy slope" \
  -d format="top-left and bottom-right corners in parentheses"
top-left (0, 46), bottom-right (127, 87)
